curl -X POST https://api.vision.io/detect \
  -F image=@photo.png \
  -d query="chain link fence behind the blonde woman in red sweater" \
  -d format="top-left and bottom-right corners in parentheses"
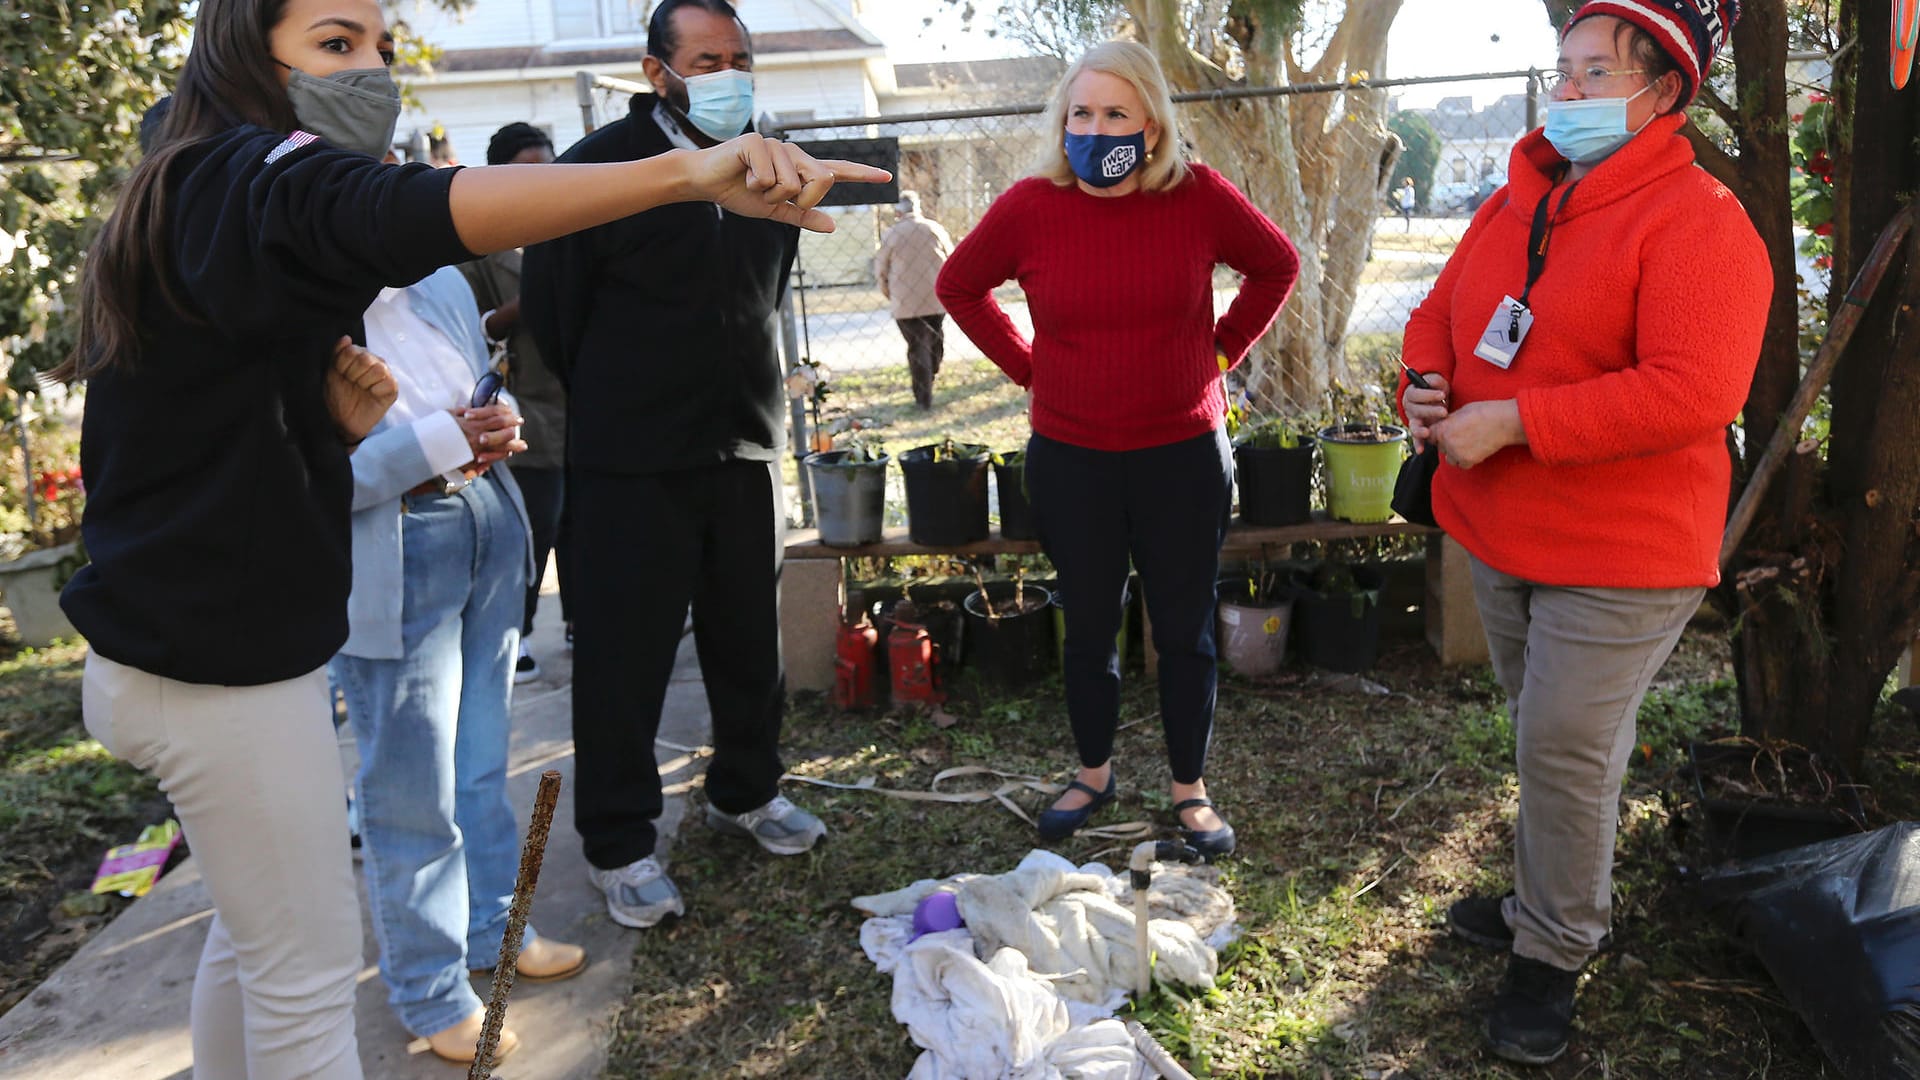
top-left (580, 71), bottom-right (1546, 499)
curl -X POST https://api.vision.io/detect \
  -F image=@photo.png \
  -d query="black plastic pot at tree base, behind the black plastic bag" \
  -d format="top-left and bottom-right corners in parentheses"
top-left (1686, 742), bottom-right (1866, 859)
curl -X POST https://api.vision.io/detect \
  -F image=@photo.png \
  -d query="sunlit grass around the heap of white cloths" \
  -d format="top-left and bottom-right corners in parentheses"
top-left (609, 630), bottom-right (1920, 1080)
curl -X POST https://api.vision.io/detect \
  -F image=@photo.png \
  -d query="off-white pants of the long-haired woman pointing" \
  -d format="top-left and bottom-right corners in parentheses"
top-left (81, 655), bottom-right (361, 1080)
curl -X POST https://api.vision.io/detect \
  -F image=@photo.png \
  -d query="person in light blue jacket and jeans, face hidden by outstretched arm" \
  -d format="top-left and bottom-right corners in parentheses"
top-left (332, 267), bottom-right (588, 1063)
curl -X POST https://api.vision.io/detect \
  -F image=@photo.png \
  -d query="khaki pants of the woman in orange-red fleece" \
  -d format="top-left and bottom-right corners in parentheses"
top-left (1473, 559), bottom-right (1705, 970)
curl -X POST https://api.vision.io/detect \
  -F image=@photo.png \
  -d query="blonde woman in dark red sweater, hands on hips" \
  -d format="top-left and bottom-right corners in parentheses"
top-left (939, 42), bottom-right (1300, 855)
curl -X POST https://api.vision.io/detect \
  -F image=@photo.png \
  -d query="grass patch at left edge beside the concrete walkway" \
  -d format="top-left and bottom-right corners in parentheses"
top-left (0, 644), bottom-right (165, 1013)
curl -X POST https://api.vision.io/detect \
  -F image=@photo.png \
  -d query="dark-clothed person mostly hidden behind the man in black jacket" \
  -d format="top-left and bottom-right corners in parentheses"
top-left (461, 123), bottom-right (570, 682)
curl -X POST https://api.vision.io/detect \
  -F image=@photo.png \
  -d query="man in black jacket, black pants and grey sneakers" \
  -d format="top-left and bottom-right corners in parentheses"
top-left (520, 0), bottom-right (826, 926)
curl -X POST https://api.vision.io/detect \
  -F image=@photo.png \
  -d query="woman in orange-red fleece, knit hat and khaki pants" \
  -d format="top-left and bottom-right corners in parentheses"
top-left (1402, 0), bottom-right (1772, 1065)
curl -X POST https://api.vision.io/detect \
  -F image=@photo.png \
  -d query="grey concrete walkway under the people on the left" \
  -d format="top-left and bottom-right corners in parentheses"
top-left (0, 582), bottom-right (708, 1080)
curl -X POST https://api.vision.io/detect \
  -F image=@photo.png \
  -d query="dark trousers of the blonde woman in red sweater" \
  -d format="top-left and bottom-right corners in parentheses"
top-left (1027, 430), bottom-right (1233, 784)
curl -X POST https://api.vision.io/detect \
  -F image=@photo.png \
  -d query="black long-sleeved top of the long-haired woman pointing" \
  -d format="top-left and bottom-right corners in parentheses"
top-left (61, 127), bottom-right (472, 686)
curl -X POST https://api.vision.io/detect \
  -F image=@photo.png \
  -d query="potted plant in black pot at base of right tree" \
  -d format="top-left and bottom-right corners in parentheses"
top-left (1682, 738), bottom-right (1866, 859)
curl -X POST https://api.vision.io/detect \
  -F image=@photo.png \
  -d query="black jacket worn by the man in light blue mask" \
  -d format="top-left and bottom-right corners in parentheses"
top-left (520, 94), bottom-right (801, 473)
